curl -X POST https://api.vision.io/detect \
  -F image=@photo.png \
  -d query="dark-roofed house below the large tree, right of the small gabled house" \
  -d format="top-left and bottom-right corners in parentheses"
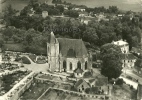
top-left (89, 76), bottom-right (109, 94)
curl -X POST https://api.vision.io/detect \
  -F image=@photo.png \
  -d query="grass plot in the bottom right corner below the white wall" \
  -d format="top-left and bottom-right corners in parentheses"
top-left (112, 84), bottom-right (136, 100)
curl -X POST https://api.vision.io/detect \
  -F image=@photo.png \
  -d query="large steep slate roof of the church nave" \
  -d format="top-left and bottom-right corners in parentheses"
top-left (57, 38), bottom-right (88, 57)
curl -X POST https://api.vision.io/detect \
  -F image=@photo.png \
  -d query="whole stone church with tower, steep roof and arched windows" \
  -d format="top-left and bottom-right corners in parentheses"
top-left (47, 32), bottom-right (92, 73)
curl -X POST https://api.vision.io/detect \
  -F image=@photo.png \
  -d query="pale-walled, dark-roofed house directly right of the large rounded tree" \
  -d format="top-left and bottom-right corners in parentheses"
top-left (121, 53), bottom-right (137, 68)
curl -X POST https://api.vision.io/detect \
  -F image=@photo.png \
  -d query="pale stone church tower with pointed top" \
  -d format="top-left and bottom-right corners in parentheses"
top-left (47, 32), bottom-right (59, 72)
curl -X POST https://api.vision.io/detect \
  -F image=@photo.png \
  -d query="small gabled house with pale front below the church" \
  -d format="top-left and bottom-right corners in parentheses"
top-left (74, 79), bottom-right (90, 92)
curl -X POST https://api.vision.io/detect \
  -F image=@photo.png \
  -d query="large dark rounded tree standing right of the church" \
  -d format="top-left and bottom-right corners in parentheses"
top-left (101, 43), bottom-right (122, 79)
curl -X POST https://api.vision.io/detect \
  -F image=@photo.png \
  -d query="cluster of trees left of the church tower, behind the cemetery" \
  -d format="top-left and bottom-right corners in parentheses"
top-left (1, 27), bottom-right (48, 55)
